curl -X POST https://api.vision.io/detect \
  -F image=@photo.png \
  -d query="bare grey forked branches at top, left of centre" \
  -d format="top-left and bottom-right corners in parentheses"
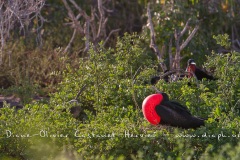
top-left (62, 0), bottom-right (119, 52)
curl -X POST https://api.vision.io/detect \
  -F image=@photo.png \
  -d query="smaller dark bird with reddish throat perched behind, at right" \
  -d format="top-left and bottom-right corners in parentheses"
top-left (186, 59), bottom-right (216, 81)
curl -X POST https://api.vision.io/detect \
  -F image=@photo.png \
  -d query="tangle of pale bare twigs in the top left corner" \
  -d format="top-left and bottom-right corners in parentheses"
top-left (0, 0), bottom-right (45, 65)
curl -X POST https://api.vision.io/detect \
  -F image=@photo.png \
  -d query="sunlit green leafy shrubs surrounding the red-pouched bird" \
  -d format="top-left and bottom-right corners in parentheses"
top-left (0, 34), bottom-right (240, 159)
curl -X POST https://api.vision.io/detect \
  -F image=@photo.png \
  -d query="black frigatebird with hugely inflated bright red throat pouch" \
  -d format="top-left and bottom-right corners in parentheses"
top-left (142, 93), bottom-right (206, 129)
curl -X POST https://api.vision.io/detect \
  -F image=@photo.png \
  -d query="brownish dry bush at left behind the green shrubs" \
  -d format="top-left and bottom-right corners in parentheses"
top-left (0, 39), bottom-right (81, 98)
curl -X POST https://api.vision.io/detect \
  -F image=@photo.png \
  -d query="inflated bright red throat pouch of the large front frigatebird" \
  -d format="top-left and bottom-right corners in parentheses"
top-left (142, 94), bottom-right (163, 125)
